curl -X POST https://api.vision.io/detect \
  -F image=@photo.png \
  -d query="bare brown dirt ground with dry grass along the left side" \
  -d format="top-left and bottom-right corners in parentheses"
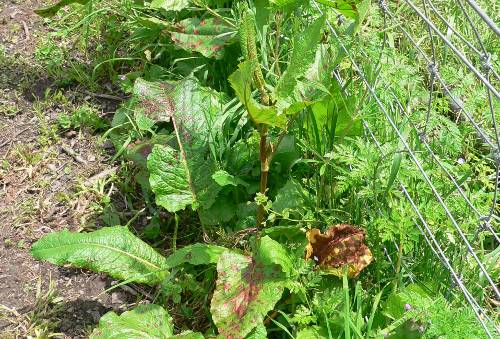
top-left (0, 0), bottom-right (134, 338)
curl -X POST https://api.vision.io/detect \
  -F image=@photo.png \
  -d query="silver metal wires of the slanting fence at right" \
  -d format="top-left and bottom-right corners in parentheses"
top-left (312, 0), bottom-right (500, 338)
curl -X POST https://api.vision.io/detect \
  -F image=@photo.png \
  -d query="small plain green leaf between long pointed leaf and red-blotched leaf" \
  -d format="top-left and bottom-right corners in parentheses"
top-left (167, 244), bottom-right (227, 267)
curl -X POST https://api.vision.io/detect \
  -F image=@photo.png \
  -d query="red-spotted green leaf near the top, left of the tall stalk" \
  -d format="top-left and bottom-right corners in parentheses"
top-left (171, 18), bottom-right (236, 59)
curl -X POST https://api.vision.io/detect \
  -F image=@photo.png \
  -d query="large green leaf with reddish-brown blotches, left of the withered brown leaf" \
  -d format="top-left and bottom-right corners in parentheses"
top-left (210, 251), bottom-right (285, 338)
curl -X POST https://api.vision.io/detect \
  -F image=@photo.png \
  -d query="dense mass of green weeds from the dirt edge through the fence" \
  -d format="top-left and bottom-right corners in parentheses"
top-left (27, 0), bottom-right (498, 338)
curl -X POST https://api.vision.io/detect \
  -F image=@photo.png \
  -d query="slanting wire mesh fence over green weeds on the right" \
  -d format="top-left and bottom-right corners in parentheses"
top-left (312, 0), bottom-right (500, 338)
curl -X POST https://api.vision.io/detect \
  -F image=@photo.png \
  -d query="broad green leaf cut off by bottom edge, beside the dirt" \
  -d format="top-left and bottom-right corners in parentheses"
top-left (90, 304), bottom-right (174, 339)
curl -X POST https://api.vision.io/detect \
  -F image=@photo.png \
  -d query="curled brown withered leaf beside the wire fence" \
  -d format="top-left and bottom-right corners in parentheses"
top-left (306, 224), bottom-right (373, 278)
